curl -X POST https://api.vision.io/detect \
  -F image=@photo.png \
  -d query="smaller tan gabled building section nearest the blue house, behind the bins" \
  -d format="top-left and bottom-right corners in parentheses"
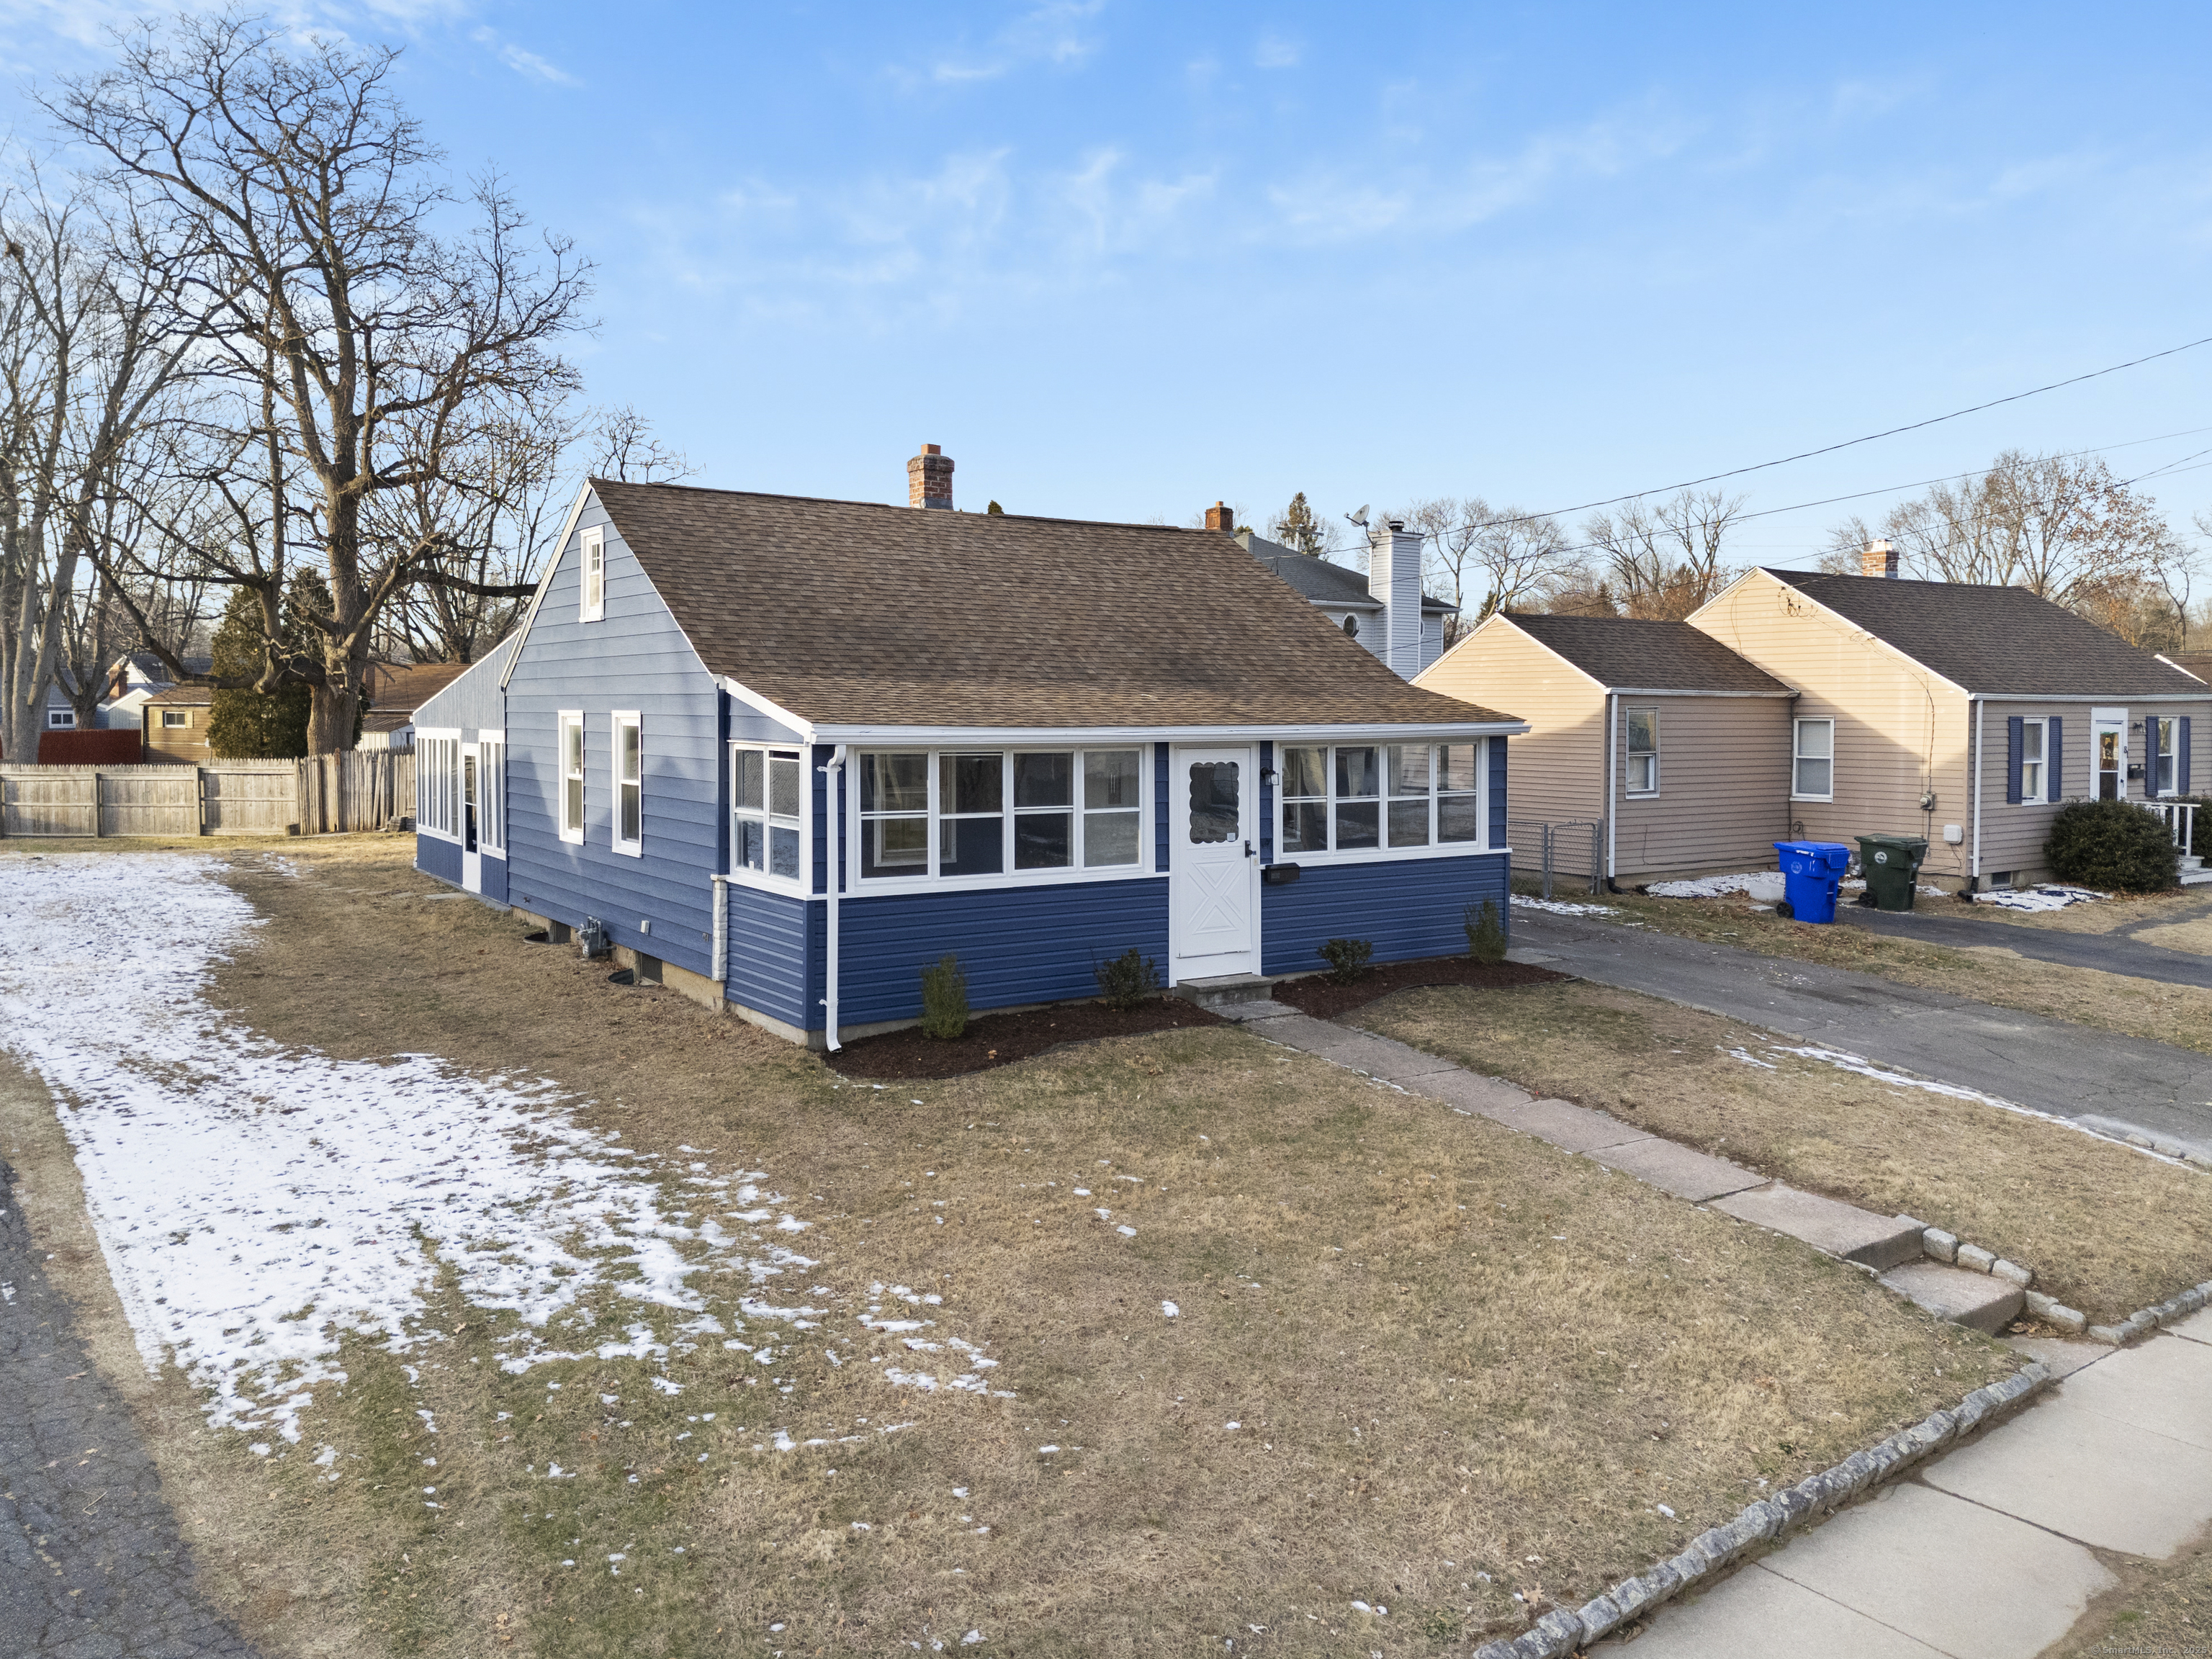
top-left (1413, 613), bottom-right (1794, 883)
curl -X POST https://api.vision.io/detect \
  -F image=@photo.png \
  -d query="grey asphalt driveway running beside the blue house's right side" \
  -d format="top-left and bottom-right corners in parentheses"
top-left (1513, 909), bottom-right (2212, 1146)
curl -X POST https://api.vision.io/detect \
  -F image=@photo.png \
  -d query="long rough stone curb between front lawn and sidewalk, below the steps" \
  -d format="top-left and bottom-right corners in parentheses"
top-left (1471, 1360), bottom-right (2053, 1659)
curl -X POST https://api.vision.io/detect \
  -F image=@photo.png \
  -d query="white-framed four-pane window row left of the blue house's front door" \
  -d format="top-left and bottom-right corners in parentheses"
top-left (856, 747), bottom-right (1143, 881)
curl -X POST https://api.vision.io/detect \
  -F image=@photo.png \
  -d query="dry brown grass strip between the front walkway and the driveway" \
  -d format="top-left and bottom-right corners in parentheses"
top-left (1356, 984), bottom-right (2212, 1321)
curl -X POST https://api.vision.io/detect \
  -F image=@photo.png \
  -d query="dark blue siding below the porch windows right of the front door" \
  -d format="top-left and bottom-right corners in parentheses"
top-left (1259, 858), bottom-right (1513, 974)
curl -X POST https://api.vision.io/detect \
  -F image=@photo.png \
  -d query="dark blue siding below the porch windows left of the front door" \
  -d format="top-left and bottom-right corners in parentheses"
top-left (827, 876), bottom-right (1168, 1026)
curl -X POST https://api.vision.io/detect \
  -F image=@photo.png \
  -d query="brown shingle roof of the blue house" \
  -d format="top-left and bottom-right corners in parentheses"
top-left (590, 480), bottom-right (1511, 728)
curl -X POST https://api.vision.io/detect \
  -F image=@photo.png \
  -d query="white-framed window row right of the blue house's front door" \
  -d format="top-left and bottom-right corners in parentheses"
top-left (1277, 743), bottom-right (1482, 858)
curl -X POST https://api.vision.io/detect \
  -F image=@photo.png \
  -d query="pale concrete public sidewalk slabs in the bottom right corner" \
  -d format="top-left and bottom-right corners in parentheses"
top-left (1591, 1310), bottom-right (2212, 1659)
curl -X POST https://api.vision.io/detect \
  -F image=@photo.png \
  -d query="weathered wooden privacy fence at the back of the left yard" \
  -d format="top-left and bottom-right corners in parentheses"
top-left (0, 752), bottom-right (413, 838)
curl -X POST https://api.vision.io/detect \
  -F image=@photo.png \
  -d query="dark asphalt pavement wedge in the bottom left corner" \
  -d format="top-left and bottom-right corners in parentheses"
top-left (0, 1164), bottom-right (254, 1659)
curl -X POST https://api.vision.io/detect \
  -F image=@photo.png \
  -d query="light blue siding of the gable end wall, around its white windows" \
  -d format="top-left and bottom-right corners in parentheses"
top-left (506, 486), bottom-right (724, 974)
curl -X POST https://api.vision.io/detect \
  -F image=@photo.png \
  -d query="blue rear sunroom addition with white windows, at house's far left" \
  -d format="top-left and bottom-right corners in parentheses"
top-left (413, 639), bottom-right (516, 904)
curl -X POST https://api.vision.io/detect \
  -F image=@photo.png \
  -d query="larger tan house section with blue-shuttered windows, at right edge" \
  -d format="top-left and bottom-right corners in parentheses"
top-left (1690, 562), bottom-right (2212, 887)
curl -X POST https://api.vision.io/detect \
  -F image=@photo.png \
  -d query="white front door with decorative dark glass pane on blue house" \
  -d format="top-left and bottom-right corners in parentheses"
top-left (1168, 747), bottom-right (1259, 984)
